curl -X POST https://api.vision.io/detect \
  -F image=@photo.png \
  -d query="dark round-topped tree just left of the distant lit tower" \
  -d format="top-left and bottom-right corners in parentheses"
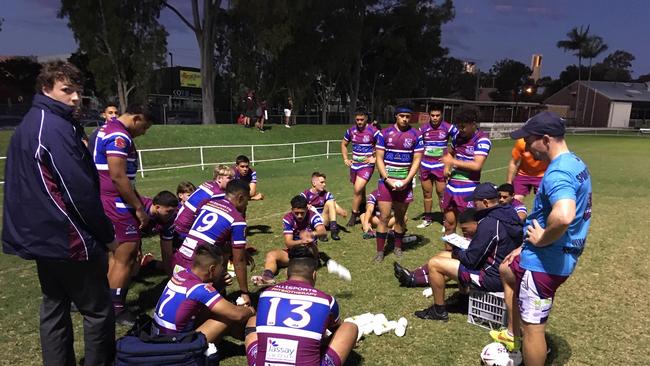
top-left (490, 58), bottom-right (533, 101)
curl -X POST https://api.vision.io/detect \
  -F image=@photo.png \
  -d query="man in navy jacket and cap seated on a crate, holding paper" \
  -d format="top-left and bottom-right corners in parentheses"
top-left (415, 183), bottom-right (523, 321)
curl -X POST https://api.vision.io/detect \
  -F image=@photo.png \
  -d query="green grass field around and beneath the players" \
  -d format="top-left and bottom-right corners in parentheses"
top-left (0, 126), bottom-right (650, 365)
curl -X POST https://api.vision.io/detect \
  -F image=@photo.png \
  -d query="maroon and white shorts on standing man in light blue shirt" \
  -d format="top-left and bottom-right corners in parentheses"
top-left (510, 256), bottom-right (569, 324)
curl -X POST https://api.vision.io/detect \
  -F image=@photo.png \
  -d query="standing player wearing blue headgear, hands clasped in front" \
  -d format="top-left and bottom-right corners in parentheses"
top-left (374, 107), bottom-right (424, 262)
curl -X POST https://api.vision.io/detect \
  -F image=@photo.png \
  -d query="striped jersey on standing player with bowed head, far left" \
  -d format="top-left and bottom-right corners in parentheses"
top-left (93, 118), bottom-right (138, 197)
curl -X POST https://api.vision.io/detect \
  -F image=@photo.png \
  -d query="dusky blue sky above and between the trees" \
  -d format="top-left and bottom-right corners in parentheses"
top-left (0, 0), bottom-right (650, 77)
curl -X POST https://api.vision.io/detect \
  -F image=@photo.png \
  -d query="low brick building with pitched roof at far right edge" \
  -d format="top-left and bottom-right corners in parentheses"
top-left (544, 81), bottom-right (650, 128)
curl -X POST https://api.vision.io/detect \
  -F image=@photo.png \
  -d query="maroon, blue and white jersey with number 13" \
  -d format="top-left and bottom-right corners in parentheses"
top-left (256, 280), bottom-right (339, 366)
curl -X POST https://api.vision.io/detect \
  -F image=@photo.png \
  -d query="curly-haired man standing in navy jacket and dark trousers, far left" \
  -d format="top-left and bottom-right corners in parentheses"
top-left (2, 61), bottom-right (115, 366)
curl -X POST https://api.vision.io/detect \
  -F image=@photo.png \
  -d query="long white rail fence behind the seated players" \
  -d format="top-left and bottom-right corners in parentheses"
top-left (138, 140), bottom-right (341, 177)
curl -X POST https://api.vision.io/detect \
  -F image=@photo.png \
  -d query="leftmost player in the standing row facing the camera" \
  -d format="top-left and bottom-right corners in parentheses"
top-left (341, 109), bottom-right (379, 227)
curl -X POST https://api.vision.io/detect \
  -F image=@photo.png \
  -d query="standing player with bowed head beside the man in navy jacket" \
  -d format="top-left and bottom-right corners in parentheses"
top-left (93, 105), bottom-right (153, 325)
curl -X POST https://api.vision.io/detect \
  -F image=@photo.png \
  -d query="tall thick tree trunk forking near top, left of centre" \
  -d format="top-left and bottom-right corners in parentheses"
top-left (163, 0), bottom-right (222, 124)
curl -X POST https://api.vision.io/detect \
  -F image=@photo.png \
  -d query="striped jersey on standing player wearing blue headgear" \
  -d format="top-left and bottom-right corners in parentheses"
top-left (377, 125), bottom-right (424, 179)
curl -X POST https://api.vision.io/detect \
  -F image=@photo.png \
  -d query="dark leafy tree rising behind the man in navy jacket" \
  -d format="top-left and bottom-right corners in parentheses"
top-left (58, 0), bottom-right (167, 112)
